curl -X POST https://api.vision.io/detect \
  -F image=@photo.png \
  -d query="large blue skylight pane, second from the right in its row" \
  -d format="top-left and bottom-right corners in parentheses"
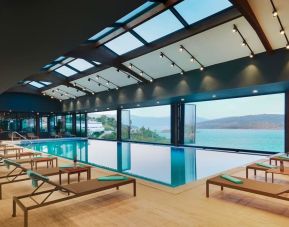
top-left (134, 10), bottom-right (184, 42)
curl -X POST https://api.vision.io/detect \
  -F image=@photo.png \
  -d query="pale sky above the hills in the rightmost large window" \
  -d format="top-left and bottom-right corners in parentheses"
top-left (189, 94), bottom-right (285, 119)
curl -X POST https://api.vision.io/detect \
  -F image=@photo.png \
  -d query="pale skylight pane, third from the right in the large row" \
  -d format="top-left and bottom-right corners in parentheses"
top-left (105, 32), bottom-right (143, 55)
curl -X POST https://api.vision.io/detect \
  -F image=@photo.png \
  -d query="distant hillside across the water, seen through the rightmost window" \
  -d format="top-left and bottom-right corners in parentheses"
top-left (197, 114), bottom-right (284, 129)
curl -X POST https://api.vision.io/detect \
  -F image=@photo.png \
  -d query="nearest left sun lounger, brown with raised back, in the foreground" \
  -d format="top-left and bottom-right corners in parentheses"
top-left (12, 173), bottom-right (136, 227)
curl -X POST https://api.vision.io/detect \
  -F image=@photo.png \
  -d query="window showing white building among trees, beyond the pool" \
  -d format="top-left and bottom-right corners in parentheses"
top-left (87, 111), bottom-right (117, 140)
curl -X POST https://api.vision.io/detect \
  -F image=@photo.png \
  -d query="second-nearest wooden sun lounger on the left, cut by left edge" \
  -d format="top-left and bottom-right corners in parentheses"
top-left (0, 160), bottom-right (60, 200)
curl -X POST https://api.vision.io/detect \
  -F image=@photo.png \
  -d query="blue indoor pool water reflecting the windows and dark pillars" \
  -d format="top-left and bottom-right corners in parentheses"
top-left (22, 139), bottom-right (264, 187)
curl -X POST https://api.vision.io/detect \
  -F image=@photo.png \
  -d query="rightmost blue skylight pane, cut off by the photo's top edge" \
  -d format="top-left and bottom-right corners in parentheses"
top-left (175, 0), bottom-right (232, 24)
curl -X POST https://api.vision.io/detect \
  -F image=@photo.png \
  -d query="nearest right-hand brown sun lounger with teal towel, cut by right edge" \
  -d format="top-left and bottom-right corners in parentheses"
top-left (206, 176), bottom-right (289, 201)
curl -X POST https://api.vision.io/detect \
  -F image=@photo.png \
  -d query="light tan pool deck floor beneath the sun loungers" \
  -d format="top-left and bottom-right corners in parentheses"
top-left (0, 153), bottom-right (289, 227)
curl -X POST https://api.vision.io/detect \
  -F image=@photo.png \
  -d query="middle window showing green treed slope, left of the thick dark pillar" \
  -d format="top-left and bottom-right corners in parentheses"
top-left (122, 105), bottom-right (171, 144)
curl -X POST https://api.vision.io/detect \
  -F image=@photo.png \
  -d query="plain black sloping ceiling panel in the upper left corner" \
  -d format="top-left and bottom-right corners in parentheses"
top-left (0, 0), bottom-right (145, 93)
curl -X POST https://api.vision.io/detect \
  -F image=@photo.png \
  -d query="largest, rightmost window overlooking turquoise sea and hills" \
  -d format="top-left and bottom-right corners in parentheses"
top-left (185, 94), bottom-right (285, 152)
